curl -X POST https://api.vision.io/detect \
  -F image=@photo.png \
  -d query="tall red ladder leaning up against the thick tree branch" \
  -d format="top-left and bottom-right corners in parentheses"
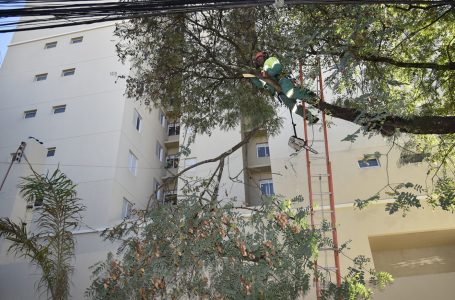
top-left (300, 59), bottom-right (341, 300)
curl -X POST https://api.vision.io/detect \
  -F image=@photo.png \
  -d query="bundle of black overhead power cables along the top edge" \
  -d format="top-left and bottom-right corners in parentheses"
top-left (0, 0), bottom-right (454, 33)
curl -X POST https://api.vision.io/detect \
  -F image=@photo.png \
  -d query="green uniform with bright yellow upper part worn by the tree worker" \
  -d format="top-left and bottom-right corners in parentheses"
top-left (251, 56), bottom-right (314, 121)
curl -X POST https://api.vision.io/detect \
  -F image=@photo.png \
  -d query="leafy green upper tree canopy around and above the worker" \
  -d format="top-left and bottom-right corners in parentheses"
top-left (116, 4), bottom-right (455, 134)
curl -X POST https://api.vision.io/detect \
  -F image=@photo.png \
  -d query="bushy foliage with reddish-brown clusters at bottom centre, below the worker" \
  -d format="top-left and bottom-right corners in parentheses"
top-left (87, 191), bottom-right (385, 299)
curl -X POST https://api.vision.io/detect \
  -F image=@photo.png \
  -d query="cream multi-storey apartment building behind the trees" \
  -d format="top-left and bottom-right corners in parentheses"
top-left (0, 24), bottom-right (455, 299)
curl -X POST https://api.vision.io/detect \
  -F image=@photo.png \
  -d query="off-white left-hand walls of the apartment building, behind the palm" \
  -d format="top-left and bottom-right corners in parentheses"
top-left (0, 22), bottom-right (164, 299)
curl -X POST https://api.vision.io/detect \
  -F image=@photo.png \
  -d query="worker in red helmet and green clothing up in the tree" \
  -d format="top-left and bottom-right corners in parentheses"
top-left (251, 51), bottom-right (319, 124)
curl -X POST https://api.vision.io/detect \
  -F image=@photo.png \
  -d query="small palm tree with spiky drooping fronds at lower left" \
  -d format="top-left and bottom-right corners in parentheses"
top-left (0, 169), bottom-right (85, 300)
